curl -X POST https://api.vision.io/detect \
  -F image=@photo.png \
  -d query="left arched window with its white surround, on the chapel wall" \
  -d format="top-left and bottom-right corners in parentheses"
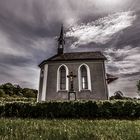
top-left (57, 65), bottom-right (68, 91)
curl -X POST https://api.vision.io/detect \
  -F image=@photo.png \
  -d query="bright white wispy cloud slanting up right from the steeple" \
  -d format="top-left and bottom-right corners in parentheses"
top-left (66, 11), bottom-right (136, 48)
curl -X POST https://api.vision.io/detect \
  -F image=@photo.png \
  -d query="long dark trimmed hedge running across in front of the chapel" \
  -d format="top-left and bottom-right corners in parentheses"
top-left (0, 101), bottom-right (140, 119)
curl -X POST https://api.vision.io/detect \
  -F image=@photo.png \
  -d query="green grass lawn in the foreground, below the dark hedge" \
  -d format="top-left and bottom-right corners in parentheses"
top-left (0, 119), bottom-right (140, 140)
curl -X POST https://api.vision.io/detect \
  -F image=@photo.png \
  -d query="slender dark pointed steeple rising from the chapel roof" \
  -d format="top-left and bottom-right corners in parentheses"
top-left (58, 24), bottom-right (65, 54)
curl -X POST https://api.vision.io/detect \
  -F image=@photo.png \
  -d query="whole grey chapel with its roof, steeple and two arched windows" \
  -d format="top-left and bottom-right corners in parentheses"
top-left (38, 26), bottom-right (116, 102)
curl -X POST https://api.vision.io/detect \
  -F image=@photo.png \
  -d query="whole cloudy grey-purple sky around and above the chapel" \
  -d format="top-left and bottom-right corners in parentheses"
top-left (0, 0), bottom-right (140, 96)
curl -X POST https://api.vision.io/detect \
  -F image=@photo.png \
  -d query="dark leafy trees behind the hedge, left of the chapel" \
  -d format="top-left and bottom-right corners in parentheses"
top-left (0, 83), bottom-right (38, 98)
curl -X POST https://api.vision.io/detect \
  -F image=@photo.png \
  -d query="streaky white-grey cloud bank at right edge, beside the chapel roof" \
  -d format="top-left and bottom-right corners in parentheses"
top-left (105, 46), bottom-right (140, 76)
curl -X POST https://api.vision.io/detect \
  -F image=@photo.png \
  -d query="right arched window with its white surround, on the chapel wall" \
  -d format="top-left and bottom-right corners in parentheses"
top-left (78, 64), bottom-right (91, 91)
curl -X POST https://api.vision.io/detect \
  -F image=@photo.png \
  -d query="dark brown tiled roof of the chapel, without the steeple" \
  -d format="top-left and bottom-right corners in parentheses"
top-left (39, 52), bottom-right (107, 66)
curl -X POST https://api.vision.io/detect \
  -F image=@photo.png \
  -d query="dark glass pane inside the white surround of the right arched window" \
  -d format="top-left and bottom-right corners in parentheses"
top-left (81, 65), bottom-right (88, 89)
